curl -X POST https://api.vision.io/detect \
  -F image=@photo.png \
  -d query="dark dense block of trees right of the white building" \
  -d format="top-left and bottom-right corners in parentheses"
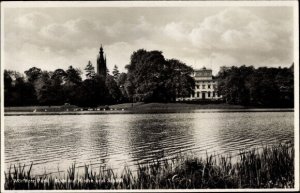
top-left (217, 64), bottom-right (294, 107)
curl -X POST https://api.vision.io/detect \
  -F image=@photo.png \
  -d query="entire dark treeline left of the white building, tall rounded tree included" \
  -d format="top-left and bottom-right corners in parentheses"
top-left (4, 50), bottom-right (194, 107)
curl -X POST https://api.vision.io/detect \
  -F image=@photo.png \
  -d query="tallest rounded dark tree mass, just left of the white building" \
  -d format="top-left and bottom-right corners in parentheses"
top-left (125, 49), bottom-right (194, 102)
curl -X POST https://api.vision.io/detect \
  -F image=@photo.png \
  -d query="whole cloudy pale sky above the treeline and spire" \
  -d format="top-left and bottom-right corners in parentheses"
top-left (4, 7), bottom-right (294, 74)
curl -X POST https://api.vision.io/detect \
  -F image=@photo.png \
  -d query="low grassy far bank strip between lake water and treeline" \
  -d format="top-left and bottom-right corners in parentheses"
top-left (4, 103), bottom-right (294, 116)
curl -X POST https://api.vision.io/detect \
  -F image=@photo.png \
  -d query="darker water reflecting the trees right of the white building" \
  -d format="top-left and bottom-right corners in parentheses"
top-left (218, 112), bottom-right (294, 153)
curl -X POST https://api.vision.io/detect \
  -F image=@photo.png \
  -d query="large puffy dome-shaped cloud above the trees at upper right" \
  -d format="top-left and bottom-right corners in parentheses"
top-left (188, 8), bottom-right (276, 52)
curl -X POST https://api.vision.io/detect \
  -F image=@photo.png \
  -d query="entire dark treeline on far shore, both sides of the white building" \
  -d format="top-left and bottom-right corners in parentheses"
top-left (4, 49), bottom-right (294, 107)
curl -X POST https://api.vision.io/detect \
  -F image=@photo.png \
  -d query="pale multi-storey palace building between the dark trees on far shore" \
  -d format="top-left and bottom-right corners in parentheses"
top-left (176, 67), bottom-right (222, 101)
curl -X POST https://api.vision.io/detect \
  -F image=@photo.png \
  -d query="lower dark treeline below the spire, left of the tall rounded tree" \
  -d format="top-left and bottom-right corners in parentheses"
top-left (4, 65), bottom-right (126, 107)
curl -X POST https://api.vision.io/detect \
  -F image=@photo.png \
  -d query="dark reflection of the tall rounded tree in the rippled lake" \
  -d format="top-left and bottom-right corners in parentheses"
top-left (129, 114), bottom-right (194, 163)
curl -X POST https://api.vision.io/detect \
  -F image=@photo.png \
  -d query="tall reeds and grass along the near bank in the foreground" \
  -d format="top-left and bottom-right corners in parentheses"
top-left (4, 144), bottom-right (294, 190)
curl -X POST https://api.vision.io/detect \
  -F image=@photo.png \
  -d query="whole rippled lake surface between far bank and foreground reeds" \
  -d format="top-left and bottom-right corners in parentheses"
top-left (4, 110), bottom-right (294, 174)
